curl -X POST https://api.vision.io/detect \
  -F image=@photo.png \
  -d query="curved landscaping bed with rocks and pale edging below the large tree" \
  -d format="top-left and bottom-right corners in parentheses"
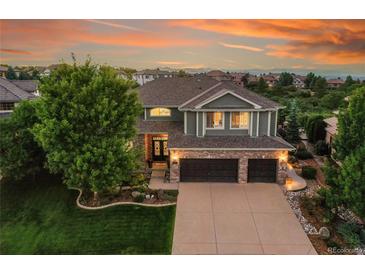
top-left (79, 187), bottom-right (178, 207)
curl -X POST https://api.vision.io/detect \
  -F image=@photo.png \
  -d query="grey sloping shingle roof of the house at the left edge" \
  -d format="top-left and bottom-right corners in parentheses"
top-left (0, 77), bottom-right (35, 102)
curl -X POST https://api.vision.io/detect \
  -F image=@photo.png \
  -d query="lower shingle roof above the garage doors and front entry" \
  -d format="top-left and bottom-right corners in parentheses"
top-left (138, 120), bottom-right (294, 150)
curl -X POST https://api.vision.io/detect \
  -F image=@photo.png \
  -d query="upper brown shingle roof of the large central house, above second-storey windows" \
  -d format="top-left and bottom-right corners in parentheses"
top-left (139, 76), bottom-right (280, 110)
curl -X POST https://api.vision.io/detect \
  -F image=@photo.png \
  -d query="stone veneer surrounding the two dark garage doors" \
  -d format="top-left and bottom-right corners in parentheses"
top-left (170, 150), bottom-right (288, 184)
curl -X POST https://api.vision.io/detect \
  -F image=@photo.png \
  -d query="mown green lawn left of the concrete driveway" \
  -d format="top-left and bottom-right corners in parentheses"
top-left (0, 175), bottom-right (175, 254)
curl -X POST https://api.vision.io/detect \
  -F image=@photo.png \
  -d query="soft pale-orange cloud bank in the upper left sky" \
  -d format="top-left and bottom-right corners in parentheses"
top-left (0, 20), bottom-right (205, 60)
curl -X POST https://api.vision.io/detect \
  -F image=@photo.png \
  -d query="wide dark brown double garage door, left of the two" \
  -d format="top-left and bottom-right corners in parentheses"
top-left (180, 159), bottom-right (238, 182)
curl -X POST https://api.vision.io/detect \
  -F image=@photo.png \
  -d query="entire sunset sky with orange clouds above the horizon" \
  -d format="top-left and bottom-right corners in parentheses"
top-left (0, 20), bottom-right (365, 75)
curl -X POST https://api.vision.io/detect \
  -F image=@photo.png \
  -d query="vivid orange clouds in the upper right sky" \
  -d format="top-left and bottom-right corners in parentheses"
top-left (170, 20), bottom-right (365, 64)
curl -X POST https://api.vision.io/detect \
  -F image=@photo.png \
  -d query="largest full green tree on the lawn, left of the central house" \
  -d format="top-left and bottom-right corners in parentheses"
top-left (33, 60), bottom-right (142, 197)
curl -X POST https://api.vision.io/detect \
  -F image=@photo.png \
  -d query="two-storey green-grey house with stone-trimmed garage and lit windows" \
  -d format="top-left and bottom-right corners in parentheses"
top-left (138, 77), bottom-right (293, 183)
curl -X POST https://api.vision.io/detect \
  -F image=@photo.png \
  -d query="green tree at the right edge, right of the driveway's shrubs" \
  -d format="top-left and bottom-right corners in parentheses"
top-left (334, 87), bottom-right (365, 160)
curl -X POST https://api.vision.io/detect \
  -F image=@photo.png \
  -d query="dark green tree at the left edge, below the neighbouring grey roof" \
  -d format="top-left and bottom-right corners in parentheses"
top-left (0, 100), bottom-right (45, 180)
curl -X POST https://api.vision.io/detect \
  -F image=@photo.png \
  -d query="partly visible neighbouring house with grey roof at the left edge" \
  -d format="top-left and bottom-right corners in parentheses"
top-left (0, 78), bottom-right (36, 117)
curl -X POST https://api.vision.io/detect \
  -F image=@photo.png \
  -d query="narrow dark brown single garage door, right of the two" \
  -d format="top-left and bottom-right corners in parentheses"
top-left (248, 159), bottom-right (277, 183)
